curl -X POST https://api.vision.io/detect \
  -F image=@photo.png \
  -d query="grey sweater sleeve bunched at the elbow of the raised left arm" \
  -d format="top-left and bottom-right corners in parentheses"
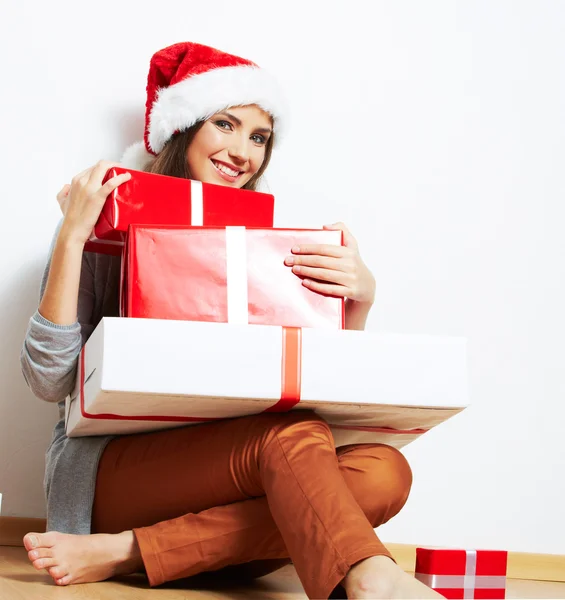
top-left (20, 221), bottom-right (95, 402)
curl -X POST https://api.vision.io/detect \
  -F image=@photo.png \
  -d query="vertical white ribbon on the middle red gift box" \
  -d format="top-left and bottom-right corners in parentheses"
top-left (226, 227), bottom-right (249, 325)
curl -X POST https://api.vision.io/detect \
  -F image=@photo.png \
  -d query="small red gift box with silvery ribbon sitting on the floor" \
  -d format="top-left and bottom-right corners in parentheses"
top-left (415, 548), bottom-right (508, 599)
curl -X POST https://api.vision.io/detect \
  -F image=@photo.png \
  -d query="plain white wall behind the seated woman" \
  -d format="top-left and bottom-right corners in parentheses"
top-left (0, 0), bottom-right (565, 554)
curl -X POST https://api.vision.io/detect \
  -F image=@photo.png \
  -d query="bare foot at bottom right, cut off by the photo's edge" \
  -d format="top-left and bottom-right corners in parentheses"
top-left (342, 556), bottom-right (443, 600)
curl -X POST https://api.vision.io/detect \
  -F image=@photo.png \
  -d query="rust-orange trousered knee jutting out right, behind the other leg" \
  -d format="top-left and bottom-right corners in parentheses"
top-left (342, 444), bottom-right (412, 527)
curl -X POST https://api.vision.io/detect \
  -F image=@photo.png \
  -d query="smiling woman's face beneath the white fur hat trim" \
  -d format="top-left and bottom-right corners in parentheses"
top-left (186, 105), bottom-right (273, 188)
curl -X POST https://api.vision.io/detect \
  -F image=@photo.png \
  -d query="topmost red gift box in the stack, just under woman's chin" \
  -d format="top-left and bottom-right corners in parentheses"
top-left (85, 167), bottom-right (275, 255)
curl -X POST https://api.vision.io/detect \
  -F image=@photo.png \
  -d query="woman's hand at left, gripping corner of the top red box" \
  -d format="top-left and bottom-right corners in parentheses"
top-left (57, 160), bottom-right (131, 244)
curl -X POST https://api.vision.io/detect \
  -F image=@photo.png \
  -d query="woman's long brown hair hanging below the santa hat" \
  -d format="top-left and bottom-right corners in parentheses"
top-left (145, 121), bottom-right (275, 191)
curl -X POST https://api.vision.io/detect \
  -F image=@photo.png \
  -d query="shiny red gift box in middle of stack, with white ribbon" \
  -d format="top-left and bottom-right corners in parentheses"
top-left (121, 225), bottom-right (344, 329)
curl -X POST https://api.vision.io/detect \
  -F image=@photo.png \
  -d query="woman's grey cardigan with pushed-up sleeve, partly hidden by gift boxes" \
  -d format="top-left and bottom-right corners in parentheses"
top-left (20, 223), bottom-right (120, 534)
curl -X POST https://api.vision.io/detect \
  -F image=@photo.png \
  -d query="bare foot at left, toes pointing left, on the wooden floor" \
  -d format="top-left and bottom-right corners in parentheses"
top-left (24, 531), bottom-right (143, 585)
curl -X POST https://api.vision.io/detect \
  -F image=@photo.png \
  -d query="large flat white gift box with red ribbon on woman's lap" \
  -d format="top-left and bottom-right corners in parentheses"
top-left (66, 317), bottom-right (468, 447)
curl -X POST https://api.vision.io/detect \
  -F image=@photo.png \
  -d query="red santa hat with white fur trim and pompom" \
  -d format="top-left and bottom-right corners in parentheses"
top-left (120, 42), bottom-right (286, 170)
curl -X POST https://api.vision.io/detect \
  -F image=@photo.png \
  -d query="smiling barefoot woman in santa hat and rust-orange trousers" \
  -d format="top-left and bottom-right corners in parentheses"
top-left (18, 43), bottom-right (439, 598)
